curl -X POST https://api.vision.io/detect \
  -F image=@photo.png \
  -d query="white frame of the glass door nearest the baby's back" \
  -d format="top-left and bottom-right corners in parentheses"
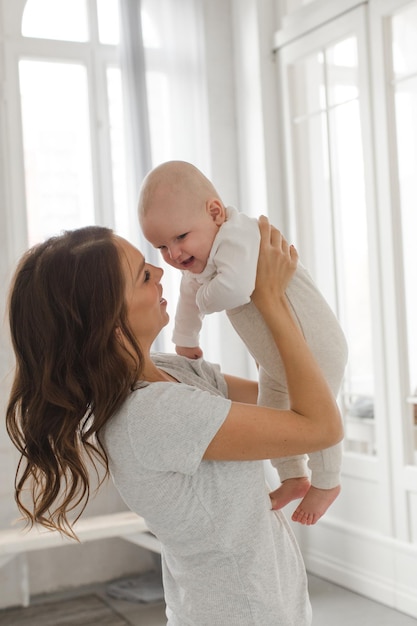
top-left (276, 1), bottom-right (393, 532)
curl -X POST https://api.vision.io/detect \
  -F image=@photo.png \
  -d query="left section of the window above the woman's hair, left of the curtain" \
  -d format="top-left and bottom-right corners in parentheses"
top-left (17, 0), bottom-right (130, 245)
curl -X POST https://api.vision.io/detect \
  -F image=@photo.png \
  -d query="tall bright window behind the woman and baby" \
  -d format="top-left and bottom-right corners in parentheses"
top-left (6, 0), bottom-right (211, 356)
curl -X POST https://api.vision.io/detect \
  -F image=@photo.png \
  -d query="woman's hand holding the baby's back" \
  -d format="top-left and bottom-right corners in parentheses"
top-left (252, 215), bottom-right (298, 312)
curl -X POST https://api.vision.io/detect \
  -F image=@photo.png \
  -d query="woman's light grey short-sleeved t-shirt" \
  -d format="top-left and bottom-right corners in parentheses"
top-left (102, 354), bottom-right (311, 626)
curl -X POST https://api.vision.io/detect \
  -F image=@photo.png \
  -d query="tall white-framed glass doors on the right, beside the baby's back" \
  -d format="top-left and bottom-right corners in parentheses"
top-left (279, 0), bottom-right (417, 542)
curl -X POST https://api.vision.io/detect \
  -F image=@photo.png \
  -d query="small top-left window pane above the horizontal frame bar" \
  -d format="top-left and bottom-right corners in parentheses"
top-left (22, 0), bottom-right (89, 41)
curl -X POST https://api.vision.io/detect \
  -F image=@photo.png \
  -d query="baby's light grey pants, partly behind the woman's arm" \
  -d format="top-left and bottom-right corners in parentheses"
top-left (227, 263), bottom-right (347, 489)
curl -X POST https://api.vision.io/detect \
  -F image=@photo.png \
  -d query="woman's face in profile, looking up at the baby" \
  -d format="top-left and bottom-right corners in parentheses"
top-left (116, 237), bottom-right (169, 350)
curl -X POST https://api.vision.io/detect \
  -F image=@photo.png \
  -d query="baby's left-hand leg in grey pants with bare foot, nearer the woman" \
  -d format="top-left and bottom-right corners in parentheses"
top-left (227, 302), bottom-right (310, 509)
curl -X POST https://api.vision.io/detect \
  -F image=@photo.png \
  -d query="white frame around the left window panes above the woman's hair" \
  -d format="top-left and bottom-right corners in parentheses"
top-left (5, 0), bottom-right (123, 255)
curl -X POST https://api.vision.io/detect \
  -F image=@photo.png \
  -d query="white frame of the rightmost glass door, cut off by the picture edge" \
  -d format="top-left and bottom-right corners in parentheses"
top-left (369, 0), bottom-right (417, 540)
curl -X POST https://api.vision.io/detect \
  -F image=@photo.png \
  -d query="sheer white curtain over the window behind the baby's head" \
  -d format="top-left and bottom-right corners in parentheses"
top-left (119, 0), bottom-right (214, 358)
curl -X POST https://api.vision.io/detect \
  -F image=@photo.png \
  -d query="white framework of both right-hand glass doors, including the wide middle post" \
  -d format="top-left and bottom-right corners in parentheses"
top-left (275, 0), bottom-right (417, 542)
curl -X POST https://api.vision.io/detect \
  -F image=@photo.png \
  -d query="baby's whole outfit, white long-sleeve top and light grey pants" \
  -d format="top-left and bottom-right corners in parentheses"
top-left (173, 207), bottom-right (347, 489)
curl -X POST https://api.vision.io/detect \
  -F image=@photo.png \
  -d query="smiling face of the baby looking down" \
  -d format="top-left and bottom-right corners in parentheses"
top-left (141, 190), bottom-right (223, 274)
